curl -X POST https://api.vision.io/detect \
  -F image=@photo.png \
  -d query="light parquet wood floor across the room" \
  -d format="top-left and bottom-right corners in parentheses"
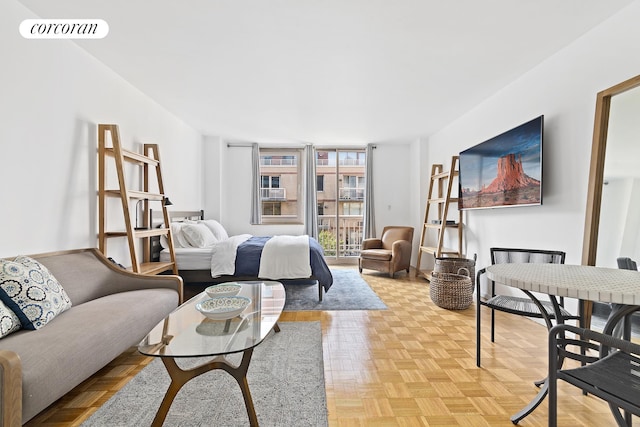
top-left (27, 271), bottom-right (637, 427)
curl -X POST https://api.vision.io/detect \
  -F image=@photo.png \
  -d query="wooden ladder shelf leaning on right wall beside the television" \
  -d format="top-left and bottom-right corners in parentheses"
top-left (416, 156), bottom-right (463, 280)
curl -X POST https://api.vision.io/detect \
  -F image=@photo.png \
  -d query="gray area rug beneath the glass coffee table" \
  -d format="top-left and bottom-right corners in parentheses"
top-left (82, 322), bottom-right (328, 427)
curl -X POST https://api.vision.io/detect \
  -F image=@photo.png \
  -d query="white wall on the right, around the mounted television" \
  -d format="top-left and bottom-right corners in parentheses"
top-left (422, 1), bottom-right (640, 308)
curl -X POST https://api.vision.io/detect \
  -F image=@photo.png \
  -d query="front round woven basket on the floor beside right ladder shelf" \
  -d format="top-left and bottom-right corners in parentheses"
top-left (429, 267), bottom-right (473, 310)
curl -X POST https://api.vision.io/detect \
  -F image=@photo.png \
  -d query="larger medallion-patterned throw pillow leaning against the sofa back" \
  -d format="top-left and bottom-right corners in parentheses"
top-left (0, 256), bottom-right (71, 330)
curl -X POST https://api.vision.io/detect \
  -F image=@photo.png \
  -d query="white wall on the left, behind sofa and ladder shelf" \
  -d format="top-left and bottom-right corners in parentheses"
top-left (0, 0), bottom-right (203, 260)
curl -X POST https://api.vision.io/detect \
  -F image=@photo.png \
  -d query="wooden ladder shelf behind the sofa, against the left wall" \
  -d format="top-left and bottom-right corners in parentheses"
top-left (98, 124), bottom-right (178, 274)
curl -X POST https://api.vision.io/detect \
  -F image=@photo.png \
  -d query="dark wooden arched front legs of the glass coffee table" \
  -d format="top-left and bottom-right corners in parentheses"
top-left (151, 348), bottom-right (258, 427)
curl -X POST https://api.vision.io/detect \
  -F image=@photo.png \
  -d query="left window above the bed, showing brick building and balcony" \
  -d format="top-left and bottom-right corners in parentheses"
top-left (260, 148), bottom-right (304, 224)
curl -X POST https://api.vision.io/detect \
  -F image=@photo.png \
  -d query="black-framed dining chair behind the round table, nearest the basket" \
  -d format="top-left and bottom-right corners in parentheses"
top-left (476, 248), bottom-right (580, 367)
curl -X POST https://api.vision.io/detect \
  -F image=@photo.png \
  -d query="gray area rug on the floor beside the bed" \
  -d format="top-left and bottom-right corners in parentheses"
top-left (284, 268), bottom-right (387, 311)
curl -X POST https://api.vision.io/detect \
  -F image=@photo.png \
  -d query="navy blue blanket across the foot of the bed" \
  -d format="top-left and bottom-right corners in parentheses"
top-left (234, 236), bottom-right (333, 292)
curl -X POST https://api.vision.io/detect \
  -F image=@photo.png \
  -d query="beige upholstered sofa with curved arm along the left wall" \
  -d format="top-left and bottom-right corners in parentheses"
top-left (0, 249), bottom-right (182, 426)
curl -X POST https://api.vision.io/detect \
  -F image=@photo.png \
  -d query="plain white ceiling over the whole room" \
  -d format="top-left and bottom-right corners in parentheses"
top-left (18, 0), bottom-right (633, 144)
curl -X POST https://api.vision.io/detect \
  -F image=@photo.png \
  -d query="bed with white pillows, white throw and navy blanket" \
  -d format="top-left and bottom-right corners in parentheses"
top-left (160, 211), bottom-right (333, 301)
